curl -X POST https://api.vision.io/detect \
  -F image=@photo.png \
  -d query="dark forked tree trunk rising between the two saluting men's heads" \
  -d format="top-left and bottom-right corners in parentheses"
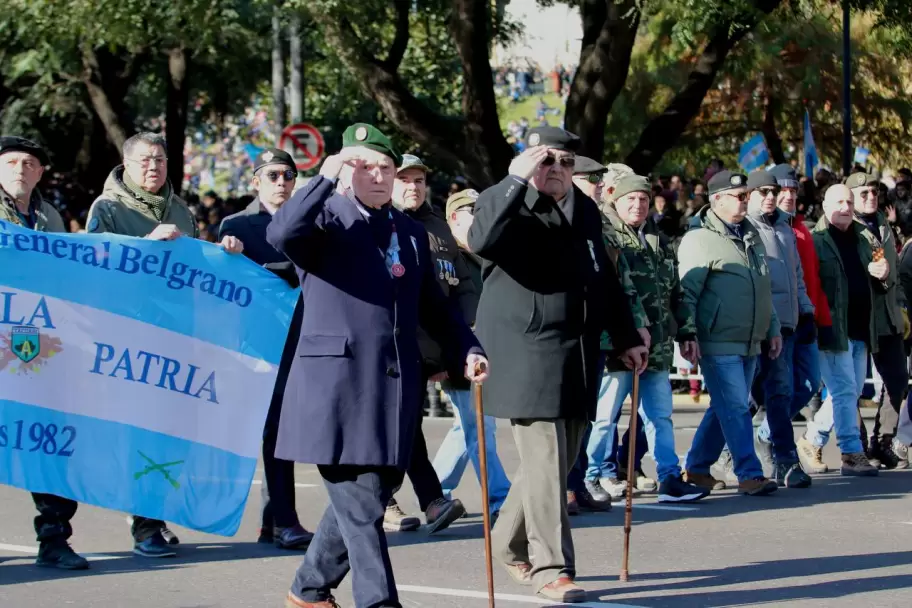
top-left (311, 0), bottom-right (513, 188)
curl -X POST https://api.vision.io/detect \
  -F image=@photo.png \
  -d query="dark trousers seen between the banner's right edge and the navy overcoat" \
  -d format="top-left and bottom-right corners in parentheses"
top-left (260, 298), bottom-right (304, 529)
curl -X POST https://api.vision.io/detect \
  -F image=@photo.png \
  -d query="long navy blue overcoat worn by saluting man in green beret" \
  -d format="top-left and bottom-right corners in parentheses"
top-left (266, 177), bottom-right (482, 469)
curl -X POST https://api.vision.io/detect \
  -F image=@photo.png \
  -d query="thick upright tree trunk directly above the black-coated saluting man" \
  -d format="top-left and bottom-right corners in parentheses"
top-left (565, 0), bottom-right (640, 161)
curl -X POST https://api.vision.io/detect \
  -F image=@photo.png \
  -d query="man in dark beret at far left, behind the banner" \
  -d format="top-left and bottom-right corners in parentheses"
top-left (0, 136), bottom-right (89, 570)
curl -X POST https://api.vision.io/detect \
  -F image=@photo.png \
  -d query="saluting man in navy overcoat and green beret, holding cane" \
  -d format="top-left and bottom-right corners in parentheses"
top-left (266, 124), bottom-right (487, 608)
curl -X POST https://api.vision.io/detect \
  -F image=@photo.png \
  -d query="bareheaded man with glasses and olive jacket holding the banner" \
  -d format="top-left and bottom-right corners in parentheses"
top-left (86, 133), bottom-right (244, 557)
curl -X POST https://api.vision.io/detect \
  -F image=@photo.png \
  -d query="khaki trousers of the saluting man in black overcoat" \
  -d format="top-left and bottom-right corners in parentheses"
top-left (491, 418), bottom-right (587, 589)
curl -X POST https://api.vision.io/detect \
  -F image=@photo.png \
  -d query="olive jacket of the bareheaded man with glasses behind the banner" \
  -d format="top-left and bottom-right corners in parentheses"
top-left (86, 165), bottom-right (199, 238)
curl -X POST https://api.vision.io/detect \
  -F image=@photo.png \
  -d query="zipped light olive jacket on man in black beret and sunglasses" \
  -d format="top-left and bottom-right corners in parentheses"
top-left (678, 205), bottom-right (780, 356)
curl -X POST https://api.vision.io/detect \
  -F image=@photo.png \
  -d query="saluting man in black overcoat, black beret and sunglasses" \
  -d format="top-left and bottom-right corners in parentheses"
top-left (468, 127), bottom-right (647, 602)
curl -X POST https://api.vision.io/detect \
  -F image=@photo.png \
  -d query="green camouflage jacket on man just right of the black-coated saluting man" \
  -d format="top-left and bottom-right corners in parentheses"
top-left (605, 208), bottom-right (697, 371)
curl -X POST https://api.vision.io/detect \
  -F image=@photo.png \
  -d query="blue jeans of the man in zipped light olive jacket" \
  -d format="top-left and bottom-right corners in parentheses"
top-left (685, 355), bottom-right (763, 481)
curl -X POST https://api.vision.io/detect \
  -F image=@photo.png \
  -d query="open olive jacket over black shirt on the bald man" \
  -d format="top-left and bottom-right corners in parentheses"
top-left (811, 217), bottom-right (880, 352)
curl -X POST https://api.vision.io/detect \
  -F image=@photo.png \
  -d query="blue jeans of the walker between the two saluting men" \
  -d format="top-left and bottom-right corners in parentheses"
top-left (433, 389), bottom-right (510, 515)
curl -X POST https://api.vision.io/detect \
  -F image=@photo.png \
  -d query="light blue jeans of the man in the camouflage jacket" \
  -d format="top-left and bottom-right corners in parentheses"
top-left (586, 371), bottom-right (681, 481)
